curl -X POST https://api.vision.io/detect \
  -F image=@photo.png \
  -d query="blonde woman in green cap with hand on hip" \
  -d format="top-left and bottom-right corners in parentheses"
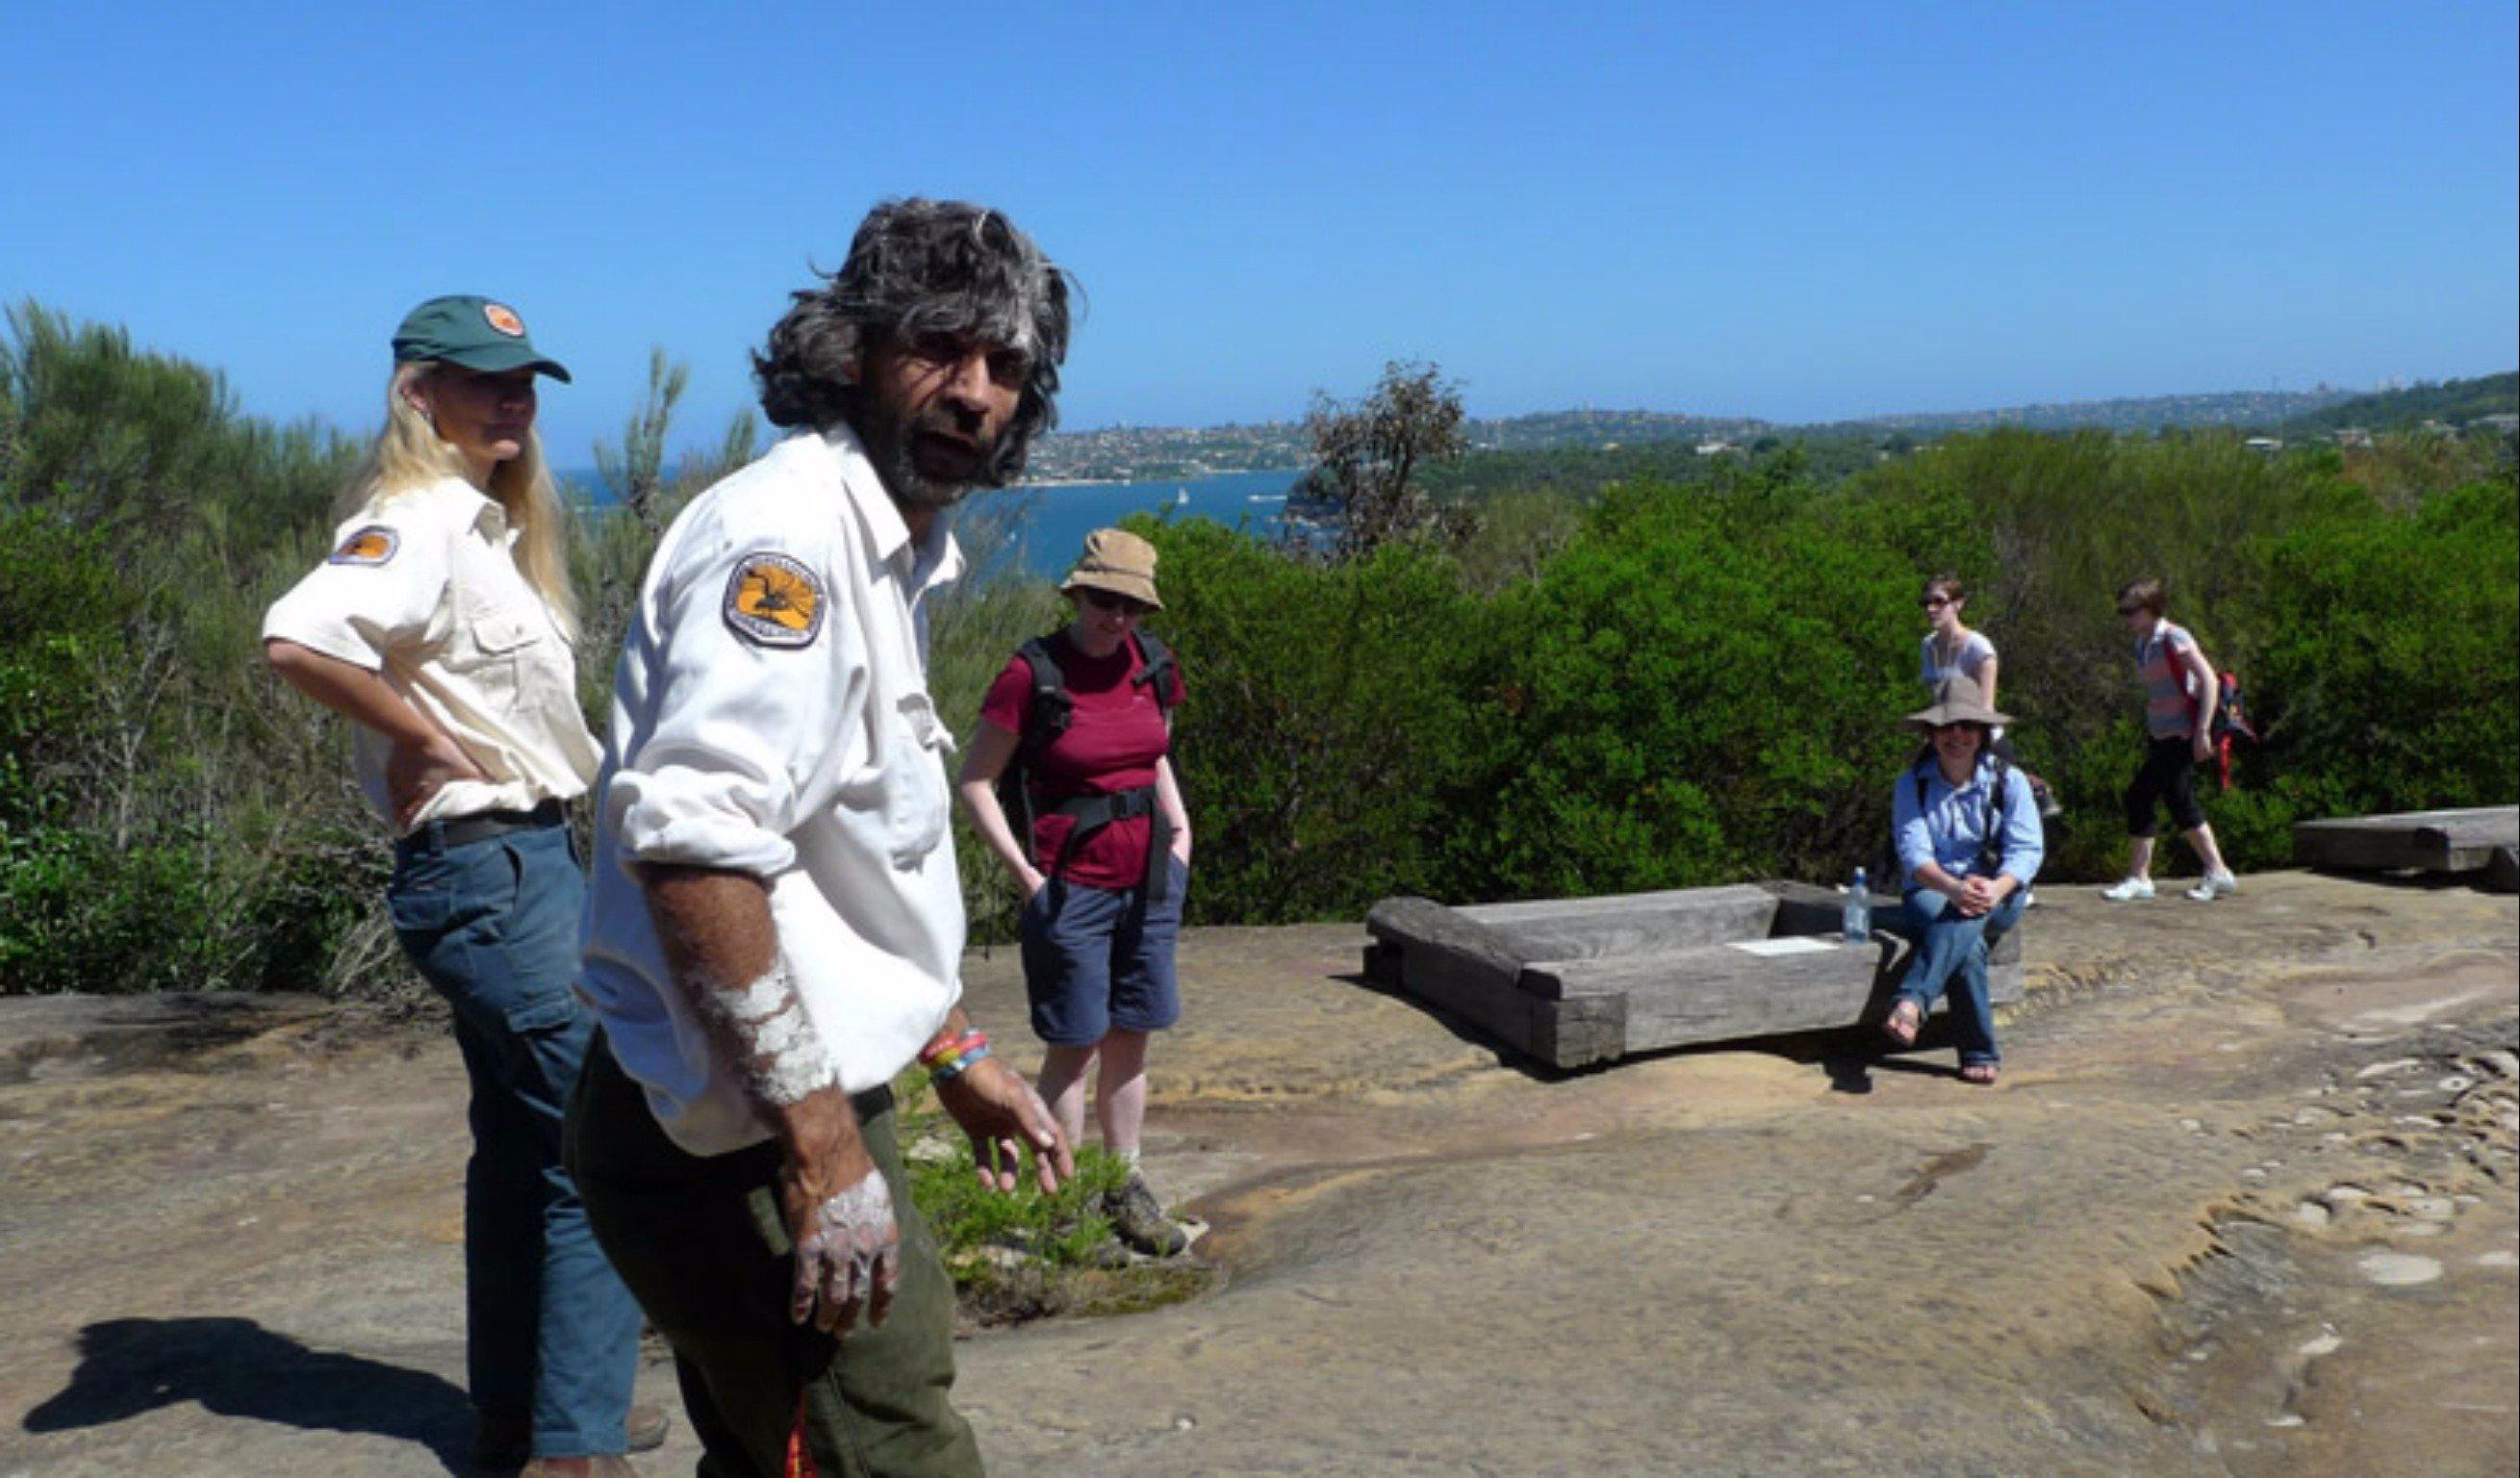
top-left (262, 297), bottom-right (665, 1475)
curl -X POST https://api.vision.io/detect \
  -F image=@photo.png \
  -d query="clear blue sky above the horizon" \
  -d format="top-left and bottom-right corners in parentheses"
top-left (0, 0), bottom-right (2520, 467)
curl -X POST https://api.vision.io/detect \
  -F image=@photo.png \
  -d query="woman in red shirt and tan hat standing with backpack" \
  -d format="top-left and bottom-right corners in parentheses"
top-left (957, 529), bottom-right (1189, 1256)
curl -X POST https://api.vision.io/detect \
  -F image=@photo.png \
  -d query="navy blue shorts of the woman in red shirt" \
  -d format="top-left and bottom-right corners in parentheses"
top-left (1023, 855), bottom-right (1189, 1047)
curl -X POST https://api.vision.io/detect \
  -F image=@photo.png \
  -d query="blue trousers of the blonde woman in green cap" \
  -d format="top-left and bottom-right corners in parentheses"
top-left (386, 825), bottom-right (640, 1458)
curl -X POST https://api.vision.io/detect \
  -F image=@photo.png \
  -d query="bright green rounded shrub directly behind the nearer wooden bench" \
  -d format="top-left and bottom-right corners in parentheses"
top-left (1446, 479), bottom-right (1913, 898)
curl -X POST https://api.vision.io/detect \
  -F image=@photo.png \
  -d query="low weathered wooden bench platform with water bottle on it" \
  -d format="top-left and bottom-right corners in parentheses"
top-left (1365, 882), bottom-right (2021, 1067)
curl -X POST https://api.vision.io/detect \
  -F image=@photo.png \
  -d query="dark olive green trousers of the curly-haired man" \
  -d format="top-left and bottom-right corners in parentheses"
top-left (565, 1039), bottom-right (980, 1478)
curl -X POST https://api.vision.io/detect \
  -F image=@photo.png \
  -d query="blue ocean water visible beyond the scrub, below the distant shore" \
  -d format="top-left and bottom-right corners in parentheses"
top-left (559, 470), bottom-right (1300, 577)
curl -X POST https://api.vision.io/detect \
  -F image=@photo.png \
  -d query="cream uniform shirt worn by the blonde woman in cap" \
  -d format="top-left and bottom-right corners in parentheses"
top-left (262, 476), bottom-right (598, 828)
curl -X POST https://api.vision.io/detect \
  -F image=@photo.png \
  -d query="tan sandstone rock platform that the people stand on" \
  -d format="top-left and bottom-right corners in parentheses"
top-left (0, 873), bottom-right (2520, 1478)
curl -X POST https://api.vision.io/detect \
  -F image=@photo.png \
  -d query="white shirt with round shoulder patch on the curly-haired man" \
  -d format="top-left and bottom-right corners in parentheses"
top-left (579, 429), bottom-right (962, 1155)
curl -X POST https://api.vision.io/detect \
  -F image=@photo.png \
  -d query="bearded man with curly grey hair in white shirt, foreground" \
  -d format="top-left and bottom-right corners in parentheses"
top-left (570, 199), bottom-right (1074, 1478)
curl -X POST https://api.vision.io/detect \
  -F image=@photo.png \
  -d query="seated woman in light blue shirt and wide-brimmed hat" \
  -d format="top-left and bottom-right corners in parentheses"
top-left (1882, 675), bottom-right (2047, 1084)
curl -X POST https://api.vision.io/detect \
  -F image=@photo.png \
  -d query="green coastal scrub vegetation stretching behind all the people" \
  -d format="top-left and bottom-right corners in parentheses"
top-left (0, 305), bottom-right (2520, 1002)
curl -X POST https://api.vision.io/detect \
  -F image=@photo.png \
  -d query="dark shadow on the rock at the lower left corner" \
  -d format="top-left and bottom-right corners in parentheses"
top-left (25, 1319), bottom-right (473, 1475)
